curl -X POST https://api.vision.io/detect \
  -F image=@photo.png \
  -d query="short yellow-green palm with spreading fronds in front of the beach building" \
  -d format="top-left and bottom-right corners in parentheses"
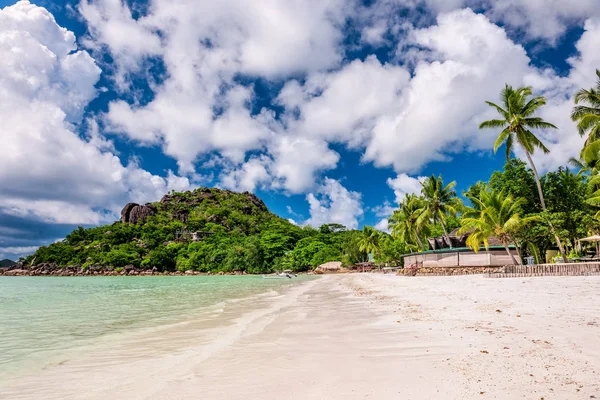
top-left (458, 188), bottom-right (539, 265)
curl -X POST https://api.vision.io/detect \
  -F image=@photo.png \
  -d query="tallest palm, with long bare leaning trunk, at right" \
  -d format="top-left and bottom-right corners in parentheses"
top-left (479, 85), bottom-right (567, 262)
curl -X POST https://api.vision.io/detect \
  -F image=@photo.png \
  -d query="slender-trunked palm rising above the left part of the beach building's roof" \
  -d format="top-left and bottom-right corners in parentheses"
top-left (421, 175), bottom-right (459, 247)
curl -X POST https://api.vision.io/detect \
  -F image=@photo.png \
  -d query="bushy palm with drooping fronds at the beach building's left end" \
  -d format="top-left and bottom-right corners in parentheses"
top-left (389, 194), bottom-right (426, 250)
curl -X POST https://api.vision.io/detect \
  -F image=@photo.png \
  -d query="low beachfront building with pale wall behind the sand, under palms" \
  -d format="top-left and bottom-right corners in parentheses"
top-left (404, 229), bottom-right (519, 268)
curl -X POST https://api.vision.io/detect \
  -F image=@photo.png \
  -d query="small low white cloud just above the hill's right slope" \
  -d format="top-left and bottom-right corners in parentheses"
top-left (304, 178), bottom-right (363, 229)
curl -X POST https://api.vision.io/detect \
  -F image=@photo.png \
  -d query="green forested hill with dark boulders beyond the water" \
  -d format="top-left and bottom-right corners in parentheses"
top-left (25, 188), bottom-right (366, 273)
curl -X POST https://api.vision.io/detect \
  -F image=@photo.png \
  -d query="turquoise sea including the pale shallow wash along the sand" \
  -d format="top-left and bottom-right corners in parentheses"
top-left (0, 276), bottom-right (314, 387)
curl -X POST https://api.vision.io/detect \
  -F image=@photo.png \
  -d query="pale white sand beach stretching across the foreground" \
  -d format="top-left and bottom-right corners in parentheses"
top-left (0, 274), bottom-right (600, 400)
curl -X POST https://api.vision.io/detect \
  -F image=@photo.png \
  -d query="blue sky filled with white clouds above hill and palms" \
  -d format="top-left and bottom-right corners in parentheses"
top-left (0, 0), bottom-right (600, 259)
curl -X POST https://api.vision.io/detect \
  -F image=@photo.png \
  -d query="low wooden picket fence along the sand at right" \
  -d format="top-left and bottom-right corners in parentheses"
top-left (486, 262), bottom-right (600, 278)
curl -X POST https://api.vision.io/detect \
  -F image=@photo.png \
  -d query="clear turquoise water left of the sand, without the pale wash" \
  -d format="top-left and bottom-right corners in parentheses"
top-left (0, 276), bottom-right (309, 376)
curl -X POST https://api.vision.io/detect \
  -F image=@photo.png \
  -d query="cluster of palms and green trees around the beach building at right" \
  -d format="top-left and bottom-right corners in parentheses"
top-left (390, 71), bottom-right (600, 262)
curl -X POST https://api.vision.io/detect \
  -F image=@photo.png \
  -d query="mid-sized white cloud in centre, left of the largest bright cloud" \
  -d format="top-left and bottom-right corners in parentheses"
top-left (279, 56), bottom-right (410, 147)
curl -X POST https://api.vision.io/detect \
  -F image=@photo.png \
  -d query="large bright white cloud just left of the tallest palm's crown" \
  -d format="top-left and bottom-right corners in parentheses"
top-left (365, 10), bottom-right (535, 172)
